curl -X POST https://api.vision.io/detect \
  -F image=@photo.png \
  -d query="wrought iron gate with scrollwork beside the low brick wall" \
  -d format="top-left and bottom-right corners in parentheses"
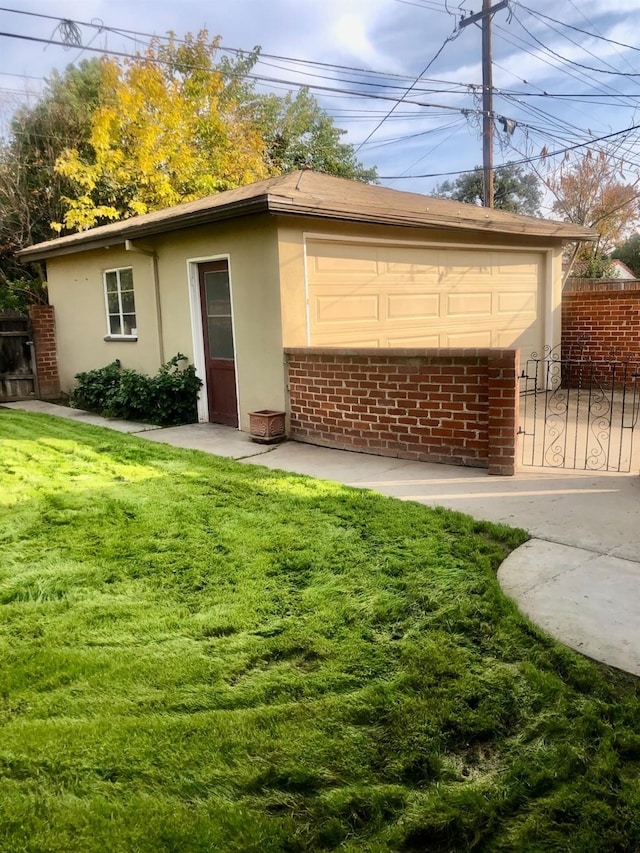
top-left (519, 349), bottom-right (640, 473)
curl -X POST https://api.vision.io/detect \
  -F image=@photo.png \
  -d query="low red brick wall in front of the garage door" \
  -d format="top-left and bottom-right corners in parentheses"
top-left (285, 348), bottom-right (518, 475)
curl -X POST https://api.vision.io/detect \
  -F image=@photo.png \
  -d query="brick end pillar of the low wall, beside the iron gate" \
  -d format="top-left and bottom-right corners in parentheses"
top-left (487, 349), bottom-right (520, 477)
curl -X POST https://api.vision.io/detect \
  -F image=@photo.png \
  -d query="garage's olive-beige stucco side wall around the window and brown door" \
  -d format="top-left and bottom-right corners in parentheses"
top-left (47, 217), bottom-right (285, 429)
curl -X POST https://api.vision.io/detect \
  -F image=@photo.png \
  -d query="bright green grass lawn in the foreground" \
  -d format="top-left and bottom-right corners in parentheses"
top-left (0, 409), bottom-right (640, 853)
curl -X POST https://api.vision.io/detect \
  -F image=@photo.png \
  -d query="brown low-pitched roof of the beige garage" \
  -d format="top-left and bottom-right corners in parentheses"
top-left (19, 171), bottom-right (597, 261)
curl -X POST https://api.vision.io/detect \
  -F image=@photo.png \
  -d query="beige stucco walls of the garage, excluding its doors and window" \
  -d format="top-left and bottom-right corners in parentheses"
top-left (47, 206), bottom-right (561, 430)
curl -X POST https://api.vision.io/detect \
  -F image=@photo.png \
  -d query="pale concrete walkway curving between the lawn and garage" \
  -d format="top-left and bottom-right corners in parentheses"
top-left (8, 402), bottom-right (640, 675)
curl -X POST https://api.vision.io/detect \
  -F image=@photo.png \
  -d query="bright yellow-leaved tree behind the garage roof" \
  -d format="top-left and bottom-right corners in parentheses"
top-left (56, 31), bottom-right (269, 230)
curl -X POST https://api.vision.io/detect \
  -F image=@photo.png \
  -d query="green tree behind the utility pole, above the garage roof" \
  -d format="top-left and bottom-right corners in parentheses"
top-left (434, 164), bottom-right (542, 216)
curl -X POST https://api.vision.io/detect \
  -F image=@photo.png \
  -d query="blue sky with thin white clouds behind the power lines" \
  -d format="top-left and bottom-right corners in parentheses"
top-left (0, 0), bottom-right (640, 213)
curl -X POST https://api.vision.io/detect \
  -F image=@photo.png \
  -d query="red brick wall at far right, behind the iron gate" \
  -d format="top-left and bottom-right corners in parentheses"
top-left (562, 285), bottom-right (640, 361)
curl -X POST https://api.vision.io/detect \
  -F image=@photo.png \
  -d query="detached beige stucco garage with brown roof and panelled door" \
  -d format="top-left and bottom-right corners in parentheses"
top-left (21, 170), bottom-right (595, 432)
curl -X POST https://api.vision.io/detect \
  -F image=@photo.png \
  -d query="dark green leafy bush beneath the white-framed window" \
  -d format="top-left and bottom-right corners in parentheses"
top-left (71, 353), bottom-right (202, 426)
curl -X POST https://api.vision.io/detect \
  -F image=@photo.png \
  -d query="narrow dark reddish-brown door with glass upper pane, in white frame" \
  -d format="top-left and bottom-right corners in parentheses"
top-left (198, 261), bottom-right (238, 426)
